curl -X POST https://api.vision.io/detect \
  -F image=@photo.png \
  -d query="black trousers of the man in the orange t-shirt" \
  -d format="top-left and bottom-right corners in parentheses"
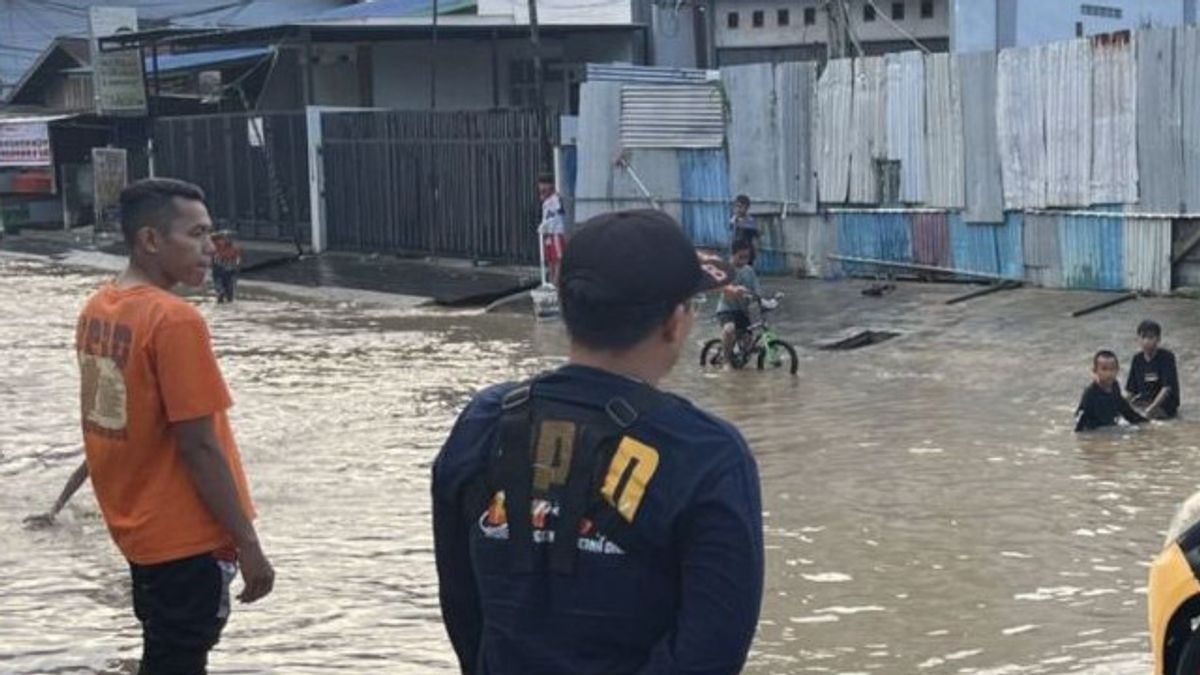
top-left (130, 554), bottom-right (236, 675)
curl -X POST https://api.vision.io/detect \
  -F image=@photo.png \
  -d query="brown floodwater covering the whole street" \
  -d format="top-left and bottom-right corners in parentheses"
top-left (0, 256), bottom-right (1200, 675)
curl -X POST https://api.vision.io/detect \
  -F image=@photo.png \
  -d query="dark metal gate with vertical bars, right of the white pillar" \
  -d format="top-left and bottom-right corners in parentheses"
top-left (322, 110), bottom-right (539, 263)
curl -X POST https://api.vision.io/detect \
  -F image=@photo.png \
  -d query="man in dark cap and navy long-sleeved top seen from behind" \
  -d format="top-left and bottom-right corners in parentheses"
top-left (433, 211), bottom-right (763, 675)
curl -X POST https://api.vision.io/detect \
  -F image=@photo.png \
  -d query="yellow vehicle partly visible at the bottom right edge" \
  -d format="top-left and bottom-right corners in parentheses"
top-left (1147, 522), bottom-right (1200, 675)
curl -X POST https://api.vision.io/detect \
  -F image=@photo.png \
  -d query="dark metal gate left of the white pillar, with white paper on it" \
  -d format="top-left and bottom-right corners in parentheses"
top-left (154, 112), bottom-right (312, 243)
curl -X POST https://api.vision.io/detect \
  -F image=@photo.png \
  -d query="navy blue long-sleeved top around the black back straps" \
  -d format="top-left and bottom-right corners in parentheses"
top-left (433, 365), bottom-right (763, 675)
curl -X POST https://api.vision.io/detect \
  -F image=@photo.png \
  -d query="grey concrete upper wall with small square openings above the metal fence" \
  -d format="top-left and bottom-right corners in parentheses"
top-left (713, 0), bottom-right (950, 48)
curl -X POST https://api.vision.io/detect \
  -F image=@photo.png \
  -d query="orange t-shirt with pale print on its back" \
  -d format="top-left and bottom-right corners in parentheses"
top-left (76, 283), bottom-right (254, 565)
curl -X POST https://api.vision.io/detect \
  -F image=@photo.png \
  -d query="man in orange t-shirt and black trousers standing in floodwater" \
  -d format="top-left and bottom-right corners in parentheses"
top-left (76, 179), bottom-right (275, 675)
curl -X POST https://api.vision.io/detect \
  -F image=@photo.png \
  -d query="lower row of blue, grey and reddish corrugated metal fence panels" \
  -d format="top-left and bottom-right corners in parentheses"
top-left (763, 207), bottom-right (1176, 293)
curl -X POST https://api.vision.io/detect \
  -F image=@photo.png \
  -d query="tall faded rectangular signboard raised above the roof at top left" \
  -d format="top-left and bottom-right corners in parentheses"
top-left (88, 7), bottom-right (146, 115)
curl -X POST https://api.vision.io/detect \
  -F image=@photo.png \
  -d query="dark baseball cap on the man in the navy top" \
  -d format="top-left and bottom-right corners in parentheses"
top-left (558, 209), bottom-right (733, 307)
